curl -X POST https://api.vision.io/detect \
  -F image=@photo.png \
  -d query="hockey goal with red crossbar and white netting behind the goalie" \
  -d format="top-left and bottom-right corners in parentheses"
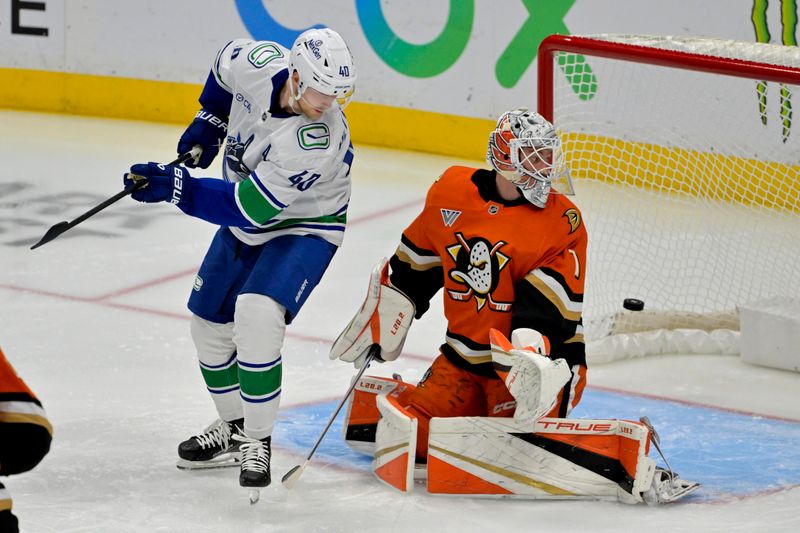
top-left (538, 35), bottom-right (800, 358)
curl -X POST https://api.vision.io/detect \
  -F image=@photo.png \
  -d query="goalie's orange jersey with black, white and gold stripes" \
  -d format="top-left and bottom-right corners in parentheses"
top-left (391, 167), bottom-right (587, 377)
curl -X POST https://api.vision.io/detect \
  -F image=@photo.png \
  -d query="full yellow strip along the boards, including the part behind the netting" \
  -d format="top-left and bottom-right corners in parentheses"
top-left (0, 68), bottom-right (800, 202)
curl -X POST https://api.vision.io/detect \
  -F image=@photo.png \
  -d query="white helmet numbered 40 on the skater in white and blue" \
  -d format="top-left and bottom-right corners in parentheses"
top-left (289, 28), bottom-right (356, 108)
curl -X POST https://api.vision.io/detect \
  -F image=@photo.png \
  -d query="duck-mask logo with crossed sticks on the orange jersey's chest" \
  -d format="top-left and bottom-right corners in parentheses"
top-left (447, 233), bottom-right (511, 312)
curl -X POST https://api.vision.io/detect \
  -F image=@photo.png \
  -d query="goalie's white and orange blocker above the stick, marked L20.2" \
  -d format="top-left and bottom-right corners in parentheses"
top-left (329, 258), bottom-right (415, 368)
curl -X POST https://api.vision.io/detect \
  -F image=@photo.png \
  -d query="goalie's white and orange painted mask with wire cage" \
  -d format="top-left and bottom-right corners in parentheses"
top-left (486, 107), bottom-right (573, 208)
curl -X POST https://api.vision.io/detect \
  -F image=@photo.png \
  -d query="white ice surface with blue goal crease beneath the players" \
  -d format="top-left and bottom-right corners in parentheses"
top-left (0, 112), bottom-right (800, 533)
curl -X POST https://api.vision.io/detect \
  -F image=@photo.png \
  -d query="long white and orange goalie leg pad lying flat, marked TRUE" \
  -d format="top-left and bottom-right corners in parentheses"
top-left (428, 417), bottom-right (655, 503)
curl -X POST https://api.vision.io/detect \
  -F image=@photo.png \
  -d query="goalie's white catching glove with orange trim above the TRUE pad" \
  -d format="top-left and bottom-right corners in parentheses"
top-left (489, 328), bottom-right (572, 421)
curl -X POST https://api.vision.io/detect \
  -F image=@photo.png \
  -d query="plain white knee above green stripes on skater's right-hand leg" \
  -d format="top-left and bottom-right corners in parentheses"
top-left (233, 293), bottom-right (286, 363)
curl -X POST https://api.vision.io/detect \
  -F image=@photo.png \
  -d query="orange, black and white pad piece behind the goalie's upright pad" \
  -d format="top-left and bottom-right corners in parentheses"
top-left (344, 376), bottom-right (415, 455)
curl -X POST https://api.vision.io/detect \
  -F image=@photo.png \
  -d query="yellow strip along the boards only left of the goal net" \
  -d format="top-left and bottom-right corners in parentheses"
top-left (0, 68), bottom-right (494, 160)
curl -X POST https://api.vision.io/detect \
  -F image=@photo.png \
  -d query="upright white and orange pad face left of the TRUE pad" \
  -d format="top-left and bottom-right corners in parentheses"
top-left (372, 395), bottom-right (417, 492)
